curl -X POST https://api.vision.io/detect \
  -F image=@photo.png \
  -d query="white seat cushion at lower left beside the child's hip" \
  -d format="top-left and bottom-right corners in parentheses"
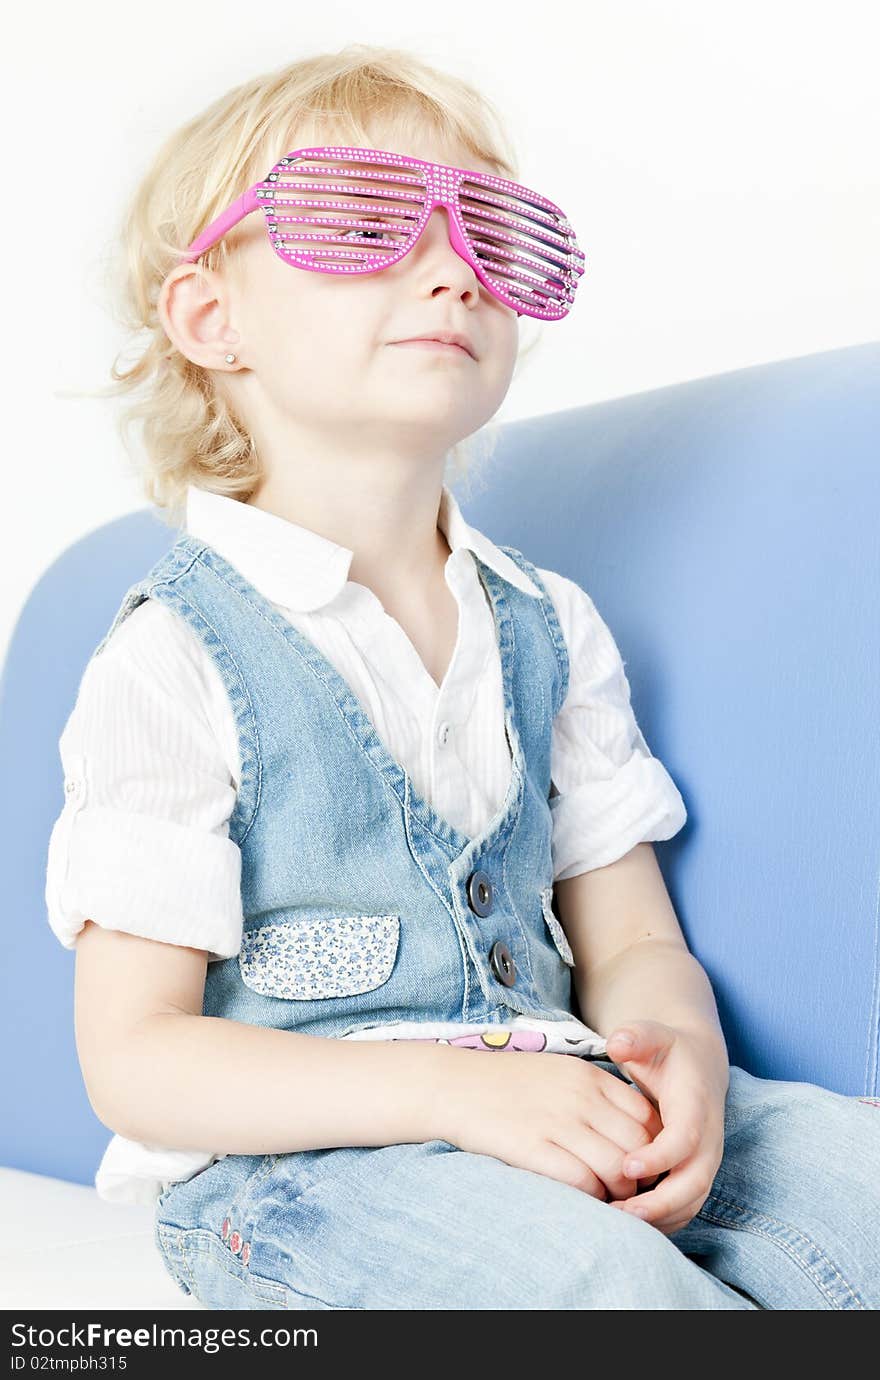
top-left (0, 1167), bottom-right (204, 1312)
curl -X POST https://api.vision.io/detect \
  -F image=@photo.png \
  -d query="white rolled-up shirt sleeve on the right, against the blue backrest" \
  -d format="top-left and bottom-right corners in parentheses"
top-left (541, 571), bottom-right (687, 880)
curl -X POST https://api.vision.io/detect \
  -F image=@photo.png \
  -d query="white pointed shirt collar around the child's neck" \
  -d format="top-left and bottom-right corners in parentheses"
top-left (185, 484), bottom-right (541, 613)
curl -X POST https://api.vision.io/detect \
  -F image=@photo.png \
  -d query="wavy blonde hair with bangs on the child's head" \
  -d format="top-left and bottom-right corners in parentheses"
top-left (74, 44), bottom-right (546, 526)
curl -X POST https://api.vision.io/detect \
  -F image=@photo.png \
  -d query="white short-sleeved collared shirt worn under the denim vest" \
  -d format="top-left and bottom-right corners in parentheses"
top-left (46, 486), bottom-right (687, 1202)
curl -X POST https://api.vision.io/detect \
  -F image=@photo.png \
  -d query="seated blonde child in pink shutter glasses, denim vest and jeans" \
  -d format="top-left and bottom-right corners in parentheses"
top-left (47, 46), bottom-right (880, 1310)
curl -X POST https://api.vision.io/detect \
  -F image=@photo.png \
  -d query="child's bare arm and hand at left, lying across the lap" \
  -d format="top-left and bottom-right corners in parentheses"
top-left (74, 920), bottom-right (661, 1198)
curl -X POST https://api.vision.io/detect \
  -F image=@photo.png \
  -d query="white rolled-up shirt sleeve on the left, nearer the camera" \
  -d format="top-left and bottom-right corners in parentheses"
top-left (46, 606), bottom-right (243, 959)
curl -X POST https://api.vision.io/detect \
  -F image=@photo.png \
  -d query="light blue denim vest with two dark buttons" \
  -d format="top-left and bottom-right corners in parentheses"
top-left (95, 533), bottom-right (572, 1036)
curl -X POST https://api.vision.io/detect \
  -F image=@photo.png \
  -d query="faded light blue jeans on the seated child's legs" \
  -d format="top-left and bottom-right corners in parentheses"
top-left (156, 1056), bottom-right (880, 1310)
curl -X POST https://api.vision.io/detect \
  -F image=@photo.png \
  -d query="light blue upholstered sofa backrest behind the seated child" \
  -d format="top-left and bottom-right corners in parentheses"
top-left (0, 342), bottom-right (880, 1203)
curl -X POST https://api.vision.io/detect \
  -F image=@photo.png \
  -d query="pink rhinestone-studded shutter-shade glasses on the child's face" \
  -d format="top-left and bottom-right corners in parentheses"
top-left (179, 144), bottom-right (586, 322)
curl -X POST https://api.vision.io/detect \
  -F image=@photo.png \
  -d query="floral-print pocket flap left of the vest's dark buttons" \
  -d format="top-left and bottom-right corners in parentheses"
top-left (239, 915), bottom-right (400, 1002)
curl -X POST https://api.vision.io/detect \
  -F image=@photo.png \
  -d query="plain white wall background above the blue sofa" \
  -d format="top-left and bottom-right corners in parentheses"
top-left (0, 0), bottom-right (880, 658)
